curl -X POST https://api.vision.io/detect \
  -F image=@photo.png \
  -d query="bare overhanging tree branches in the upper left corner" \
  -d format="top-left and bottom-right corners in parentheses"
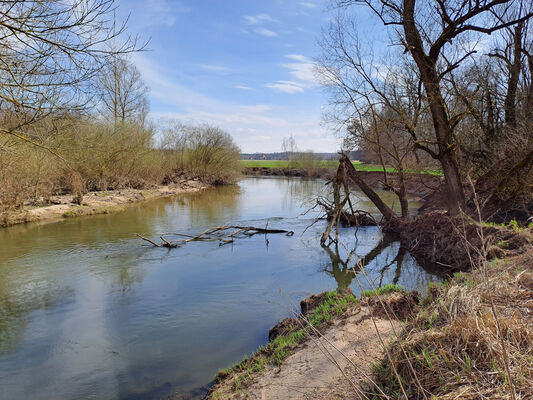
top-left (0, 0), bottom-right (142, 145)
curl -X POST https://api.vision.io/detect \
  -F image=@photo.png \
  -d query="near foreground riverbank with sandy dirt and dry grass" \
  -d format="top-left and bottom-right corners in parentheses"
top-left (206, 242), bottom-right (533, 400)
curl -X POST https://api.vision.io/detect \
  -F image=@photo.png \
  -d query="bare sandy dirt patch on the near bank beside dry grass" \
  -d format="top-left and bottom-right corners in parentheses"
top-left (211, 307), bottom-right (400, 400)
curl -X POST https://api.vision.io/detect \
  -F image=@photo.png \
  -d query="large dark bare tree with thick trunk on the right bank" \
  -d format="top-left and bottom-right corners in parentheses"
top-left (335, 0), bottom-right (533, 215)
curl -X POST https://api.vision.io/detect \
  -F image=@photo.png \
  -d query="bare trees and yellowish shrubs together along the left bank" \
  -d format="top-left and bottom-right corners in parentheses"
top-left (0, 0), bottom-right (239, 217)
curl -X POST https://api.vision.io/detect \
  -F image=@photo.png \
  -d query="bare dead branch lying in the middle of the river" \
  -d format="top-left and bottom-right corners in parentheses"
top-left (137, 225), bottom-right (294, 249)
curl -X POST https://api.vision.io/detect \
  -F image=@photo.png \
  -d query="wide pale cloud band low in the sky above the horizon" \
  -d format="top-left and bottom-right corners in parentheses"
top-left (133, 53), bottom-right (339, 153)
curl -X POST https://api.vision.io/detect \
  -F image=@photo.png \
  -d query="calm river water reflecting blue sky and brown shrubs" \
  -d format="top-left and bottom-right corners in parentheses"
top-left (0, 178), bottom-right (439, 400)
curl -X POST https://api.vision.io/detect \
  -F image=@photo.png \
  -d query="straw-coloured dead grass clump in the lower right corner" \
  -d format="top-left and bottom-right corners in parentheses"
top-left (375, 255), bottom-right (533, 399)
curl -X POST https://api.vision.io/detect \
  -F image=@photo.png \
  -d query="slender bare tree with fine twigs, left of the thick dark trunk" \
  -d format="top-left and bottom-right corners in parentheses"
top-left (318, 15), bottom-right (431, 218)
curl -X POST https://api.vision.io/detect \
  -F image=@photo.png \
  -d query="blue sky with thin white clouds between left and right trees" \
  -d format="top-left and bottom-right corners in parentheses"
top-left (118, 0), bottom-right (340, 153)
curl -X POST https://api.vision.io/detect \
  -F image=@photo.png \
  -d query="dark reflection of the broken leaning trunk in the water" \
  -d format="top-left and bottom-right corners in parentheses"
top-left (323, 235), bottom-right (407, 290)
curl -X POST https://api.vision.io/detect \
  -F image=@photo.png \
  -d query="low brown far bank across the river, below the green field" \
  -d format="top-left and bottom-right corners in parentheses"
top-left (244, 167), bottom-right (444, 198)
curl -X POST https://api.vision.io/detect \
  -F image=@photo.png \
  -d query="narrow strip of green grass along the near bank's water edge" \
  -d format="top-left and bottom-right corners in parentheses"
top-left (208, 291), bottom-right (357, 399)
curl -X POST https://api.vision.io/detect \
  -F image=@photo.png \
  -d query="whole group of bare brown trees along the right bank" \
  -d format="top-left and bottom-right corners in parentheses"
top-left (319, 0), bottom-right (533, 219)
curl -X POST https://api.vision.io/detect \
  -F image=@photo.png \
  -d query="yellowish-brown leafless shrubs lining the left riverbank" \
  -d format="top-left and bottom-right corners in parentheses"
top-left (0, 118), bottom-right (240, 226)
